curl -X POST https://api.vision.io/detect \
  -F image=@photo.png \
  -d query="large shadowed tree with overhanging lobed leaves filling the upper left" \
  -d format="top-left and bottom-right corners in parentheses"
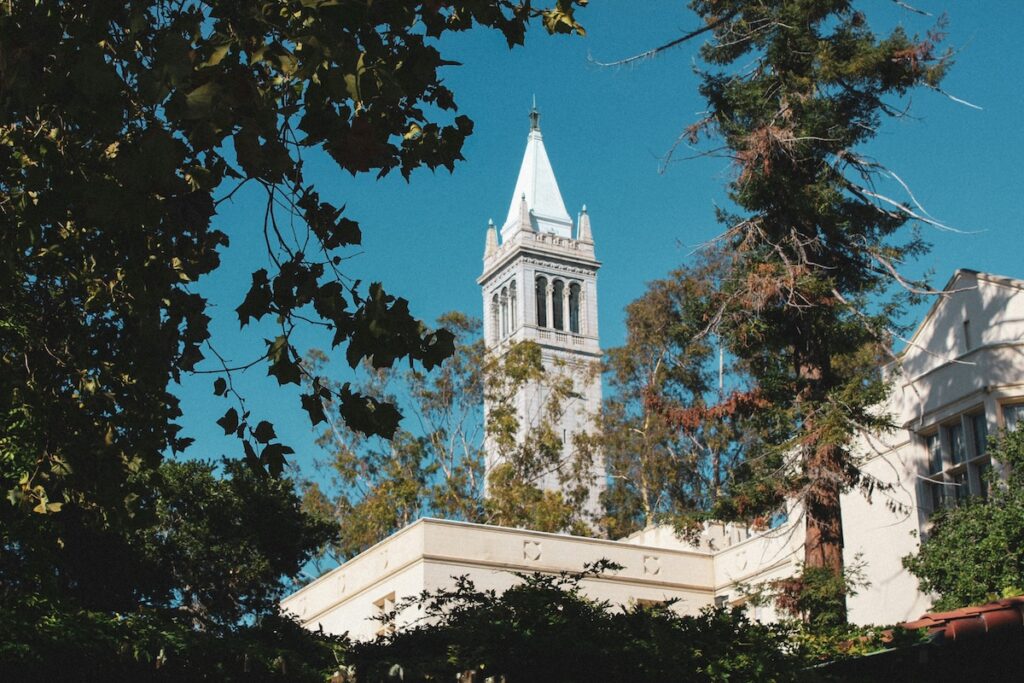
top-left (0, 0), bottom-right (586, 667)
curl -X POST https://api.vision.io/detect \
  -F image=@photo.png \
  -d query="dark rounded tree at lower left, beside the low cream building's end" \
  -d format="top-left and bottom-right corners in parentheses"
top-left (0, 461), bottom-right (338, 681)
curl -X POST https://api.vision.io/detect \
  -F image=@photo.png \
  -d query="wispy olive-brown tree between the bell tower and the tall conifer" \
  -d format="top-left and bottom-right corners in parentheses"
top-left (601, 253), bottom-right (756, 537)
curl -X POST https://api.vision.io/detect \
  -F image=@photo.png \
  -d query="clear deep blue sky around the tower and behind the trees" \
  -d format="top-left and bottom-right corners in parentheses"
top-left (179, 0), bottom-right (1024, 475)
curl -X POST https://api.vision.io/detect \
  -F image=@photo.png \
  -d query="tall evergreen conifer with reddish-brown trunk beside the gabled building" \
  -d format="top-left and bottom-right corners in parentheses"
top-left (671, 0), bottom-right (949, 622)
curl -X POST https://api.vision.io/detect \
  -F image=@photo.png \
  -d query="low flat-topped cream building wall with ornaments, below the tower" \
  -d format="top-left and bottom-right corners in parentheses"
top-left (282, 519), bottom-right (714, 639)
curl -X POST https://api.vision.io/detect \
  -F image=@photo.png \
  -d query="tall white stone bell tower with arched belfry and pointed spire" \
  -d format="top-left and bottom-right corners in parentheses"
top-left (477, 105), bottom-right (605, 513)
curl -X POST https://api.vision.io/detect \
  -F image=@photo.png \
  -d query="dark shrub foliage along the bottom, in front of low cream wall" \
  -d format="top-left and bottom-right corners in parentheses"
top-left (345, 562), bottom-right (803, 683)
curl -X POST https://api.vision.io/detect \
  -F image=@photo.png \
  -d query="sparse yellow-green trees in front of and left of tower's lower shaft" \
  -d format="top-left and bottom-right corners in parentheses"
top-left (304, 312), bottom-right (593, 561)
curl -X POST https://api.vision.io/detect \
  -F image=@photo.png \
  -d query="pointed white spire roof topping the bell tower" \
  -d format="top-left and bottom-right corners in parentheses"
top-left (502, 103), bottom-right (572, 241)
